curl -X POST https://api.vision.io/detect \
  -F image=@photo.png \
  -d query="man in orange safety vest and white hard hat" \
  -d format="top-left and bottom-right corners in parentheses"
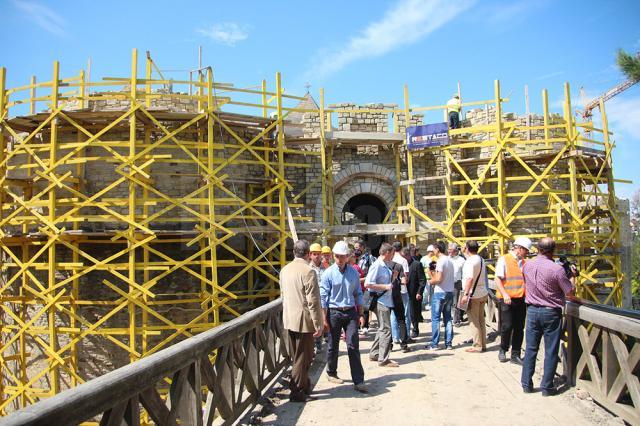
top-left (495, 237), bottom-right (531, 365)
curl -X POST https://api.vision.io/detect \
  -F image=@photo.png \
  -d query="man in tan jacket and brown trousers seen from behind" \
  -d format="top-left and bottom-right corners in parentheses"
top-left (280, 240), bottom-right (324, 402)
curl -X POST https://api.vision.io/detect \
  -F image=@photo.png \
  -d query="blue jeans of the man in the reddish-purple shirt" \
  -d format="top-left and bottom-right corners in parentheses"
top-left (520, 306), bottom-right (562, 391)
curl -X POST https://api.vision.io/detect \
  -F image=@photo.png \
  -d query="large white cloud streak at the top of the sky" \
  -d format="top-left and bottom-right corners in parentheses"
top-left (305, 0), bottom-right (475, 80)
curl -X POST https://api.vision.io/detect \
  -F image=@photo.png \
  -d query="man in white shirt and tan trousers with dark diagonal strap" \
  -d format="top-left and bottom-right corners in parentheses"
top-left (461, 240), bottom-right (488, 352)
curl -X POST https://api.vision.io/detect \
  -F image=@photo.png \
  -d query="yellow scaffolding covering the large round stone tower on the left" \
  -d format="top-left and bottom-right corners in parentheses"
top-left (0, 50), bottom-right (320, 414)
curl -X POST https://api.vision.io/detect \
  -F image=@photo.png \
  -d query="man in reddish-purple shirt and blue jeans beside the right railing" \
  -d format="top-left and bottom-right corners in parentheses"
top-left (521, 238), bottom-right (577, 396)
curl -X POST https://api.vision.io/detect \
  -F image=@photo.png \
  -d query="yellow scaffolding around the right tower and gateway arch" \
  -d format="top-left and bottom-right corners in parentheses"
top-left (307, 80), bottom-right (627, 306)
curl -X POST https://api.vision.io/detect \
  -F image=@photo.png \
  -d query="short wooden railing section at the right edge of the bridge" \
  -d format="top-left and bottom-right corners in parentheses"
top-left (564, 300), bottom-right (640, 425)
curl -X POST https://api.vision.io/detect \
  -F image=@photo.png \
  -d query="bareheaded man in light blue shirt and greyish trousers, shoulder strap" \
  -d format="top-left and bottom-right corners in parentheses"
top-left (364, 243), bottom-right (398, 367)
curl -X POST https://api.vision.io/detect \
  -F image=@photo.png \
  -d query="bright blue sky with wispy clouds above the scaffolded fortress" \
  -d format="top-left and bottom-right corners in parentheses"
top-left (0, 0), bottom-right (640, 197)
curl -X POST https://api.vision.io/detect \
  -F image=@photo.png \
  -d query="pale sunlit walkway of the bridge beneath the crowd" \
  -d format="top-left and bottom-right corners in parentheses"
top-left (249, 324), bottom-right (623, 426)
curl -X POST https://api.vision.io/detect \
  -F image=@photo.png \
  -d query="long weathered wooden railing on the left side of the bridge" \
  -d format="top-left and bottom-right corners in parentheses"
top-left (0, 299), bottom-right (289, 425)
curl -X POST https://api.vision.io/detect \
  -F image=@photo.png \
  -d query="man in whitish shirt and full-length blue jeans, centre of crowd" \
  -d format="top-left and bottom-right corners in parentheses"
top-left (429, 241), bottom-right (454, 350)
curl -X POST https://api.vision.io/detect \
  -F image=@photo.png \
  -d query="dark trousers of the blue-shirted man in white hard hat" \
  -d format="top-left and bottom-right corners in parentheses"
top-left (327, 308), bottom-right (364, 385)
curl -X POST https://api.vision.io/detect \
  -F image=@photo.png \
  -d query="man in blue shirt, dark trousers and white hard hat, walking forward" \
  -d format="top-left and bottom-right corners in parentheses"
top-left (320, 241), bottom-right (368, 393)
